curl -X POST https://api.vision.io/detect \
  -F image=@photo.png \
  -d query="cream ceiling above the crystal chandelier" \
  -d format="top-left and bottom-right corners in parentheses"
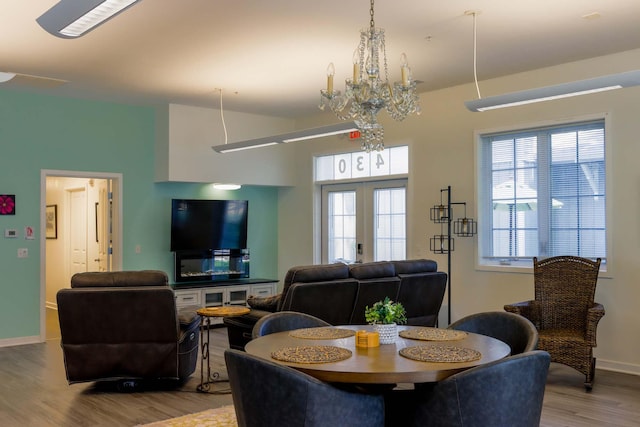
top-left (0, 0), bottom-right (640, 118)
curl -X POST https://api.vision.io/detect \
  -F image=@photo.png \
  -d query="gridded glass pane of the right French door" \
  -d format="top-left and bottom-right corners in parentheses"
top-left (373, 187), bottom-right (407, 261)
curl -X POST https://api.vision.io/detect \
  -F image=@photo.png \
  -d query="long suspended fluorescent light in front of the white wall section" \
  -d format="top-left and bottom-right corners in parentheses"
top-left (211, 122), bottom-right (358, 153)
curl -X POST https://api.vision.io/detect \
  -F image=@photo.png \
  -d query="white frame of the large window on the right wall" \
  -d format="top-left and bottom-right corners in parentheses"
top-left (473, 113), bottom-right (614, 277)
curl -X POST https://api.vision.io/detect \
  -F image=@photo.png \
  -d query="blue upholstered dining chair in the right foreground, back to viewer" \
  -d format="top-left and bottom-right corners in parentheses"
top-left (386, 350), bottom-right (551, 427)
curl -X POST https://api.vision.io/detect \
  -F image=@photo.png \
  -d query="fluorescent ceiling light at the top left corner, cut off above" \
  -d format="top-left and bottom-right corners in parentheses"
top-left (36, 0), bottom-right (140, 39)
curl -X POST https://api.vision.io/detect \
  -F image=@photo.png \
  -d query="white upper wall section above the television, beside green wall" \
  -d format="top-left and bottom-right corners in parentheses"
top-left (156, 104), bottom-right (295, 186)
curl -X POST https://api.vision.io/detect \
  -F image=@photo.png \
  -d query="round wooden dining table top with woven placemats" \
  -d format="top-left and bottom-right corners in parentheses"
top-left (245, 325), bottom-right (511, 384)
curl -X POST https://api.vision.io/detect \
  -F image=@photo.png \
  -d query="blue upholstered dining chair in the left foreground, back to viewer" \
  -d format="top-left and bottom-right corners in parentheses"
top-left (224, 349), bottom-right (384, 427)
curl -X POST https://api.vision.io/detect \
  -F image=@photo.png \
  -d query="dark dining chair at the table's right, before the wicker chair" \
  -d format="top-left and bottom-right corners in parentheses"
top-left (448, 311), bottom-right (538, 356)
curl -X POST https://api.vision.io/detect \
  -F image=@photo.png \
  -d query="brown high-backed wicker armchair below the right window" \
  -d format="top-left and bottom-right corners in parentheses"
top-left (504, 256), bottom-right (604, 391)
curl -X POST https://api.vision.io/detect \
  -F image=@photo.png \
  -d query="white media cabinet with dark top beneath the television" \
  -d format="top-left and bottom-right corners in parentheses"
top-left (174, 282), bottom-right (277, 325)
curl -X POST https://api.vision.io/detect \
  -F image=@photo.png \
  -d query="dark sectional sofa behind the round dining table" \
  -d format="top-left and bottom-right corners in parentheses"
top-left (223, 259), bottom-right (447, 350)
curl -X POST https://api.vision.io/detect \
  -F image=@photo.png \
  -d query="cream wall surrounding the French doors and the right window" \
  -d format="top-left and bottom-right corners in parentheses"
top-left (279, 51), bottom-right (640, 374)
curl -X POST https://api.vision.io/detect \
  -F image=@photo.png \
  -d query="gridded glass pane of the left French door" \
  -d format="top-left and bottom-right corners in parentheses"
top-left (327, 191), bottom-right (356, 262)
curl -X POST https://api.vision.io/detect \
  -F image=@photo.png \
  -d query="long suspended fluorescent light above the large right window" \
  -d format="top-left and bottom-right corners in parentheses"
top-left (464, 70), bottom-right (640, 111)
